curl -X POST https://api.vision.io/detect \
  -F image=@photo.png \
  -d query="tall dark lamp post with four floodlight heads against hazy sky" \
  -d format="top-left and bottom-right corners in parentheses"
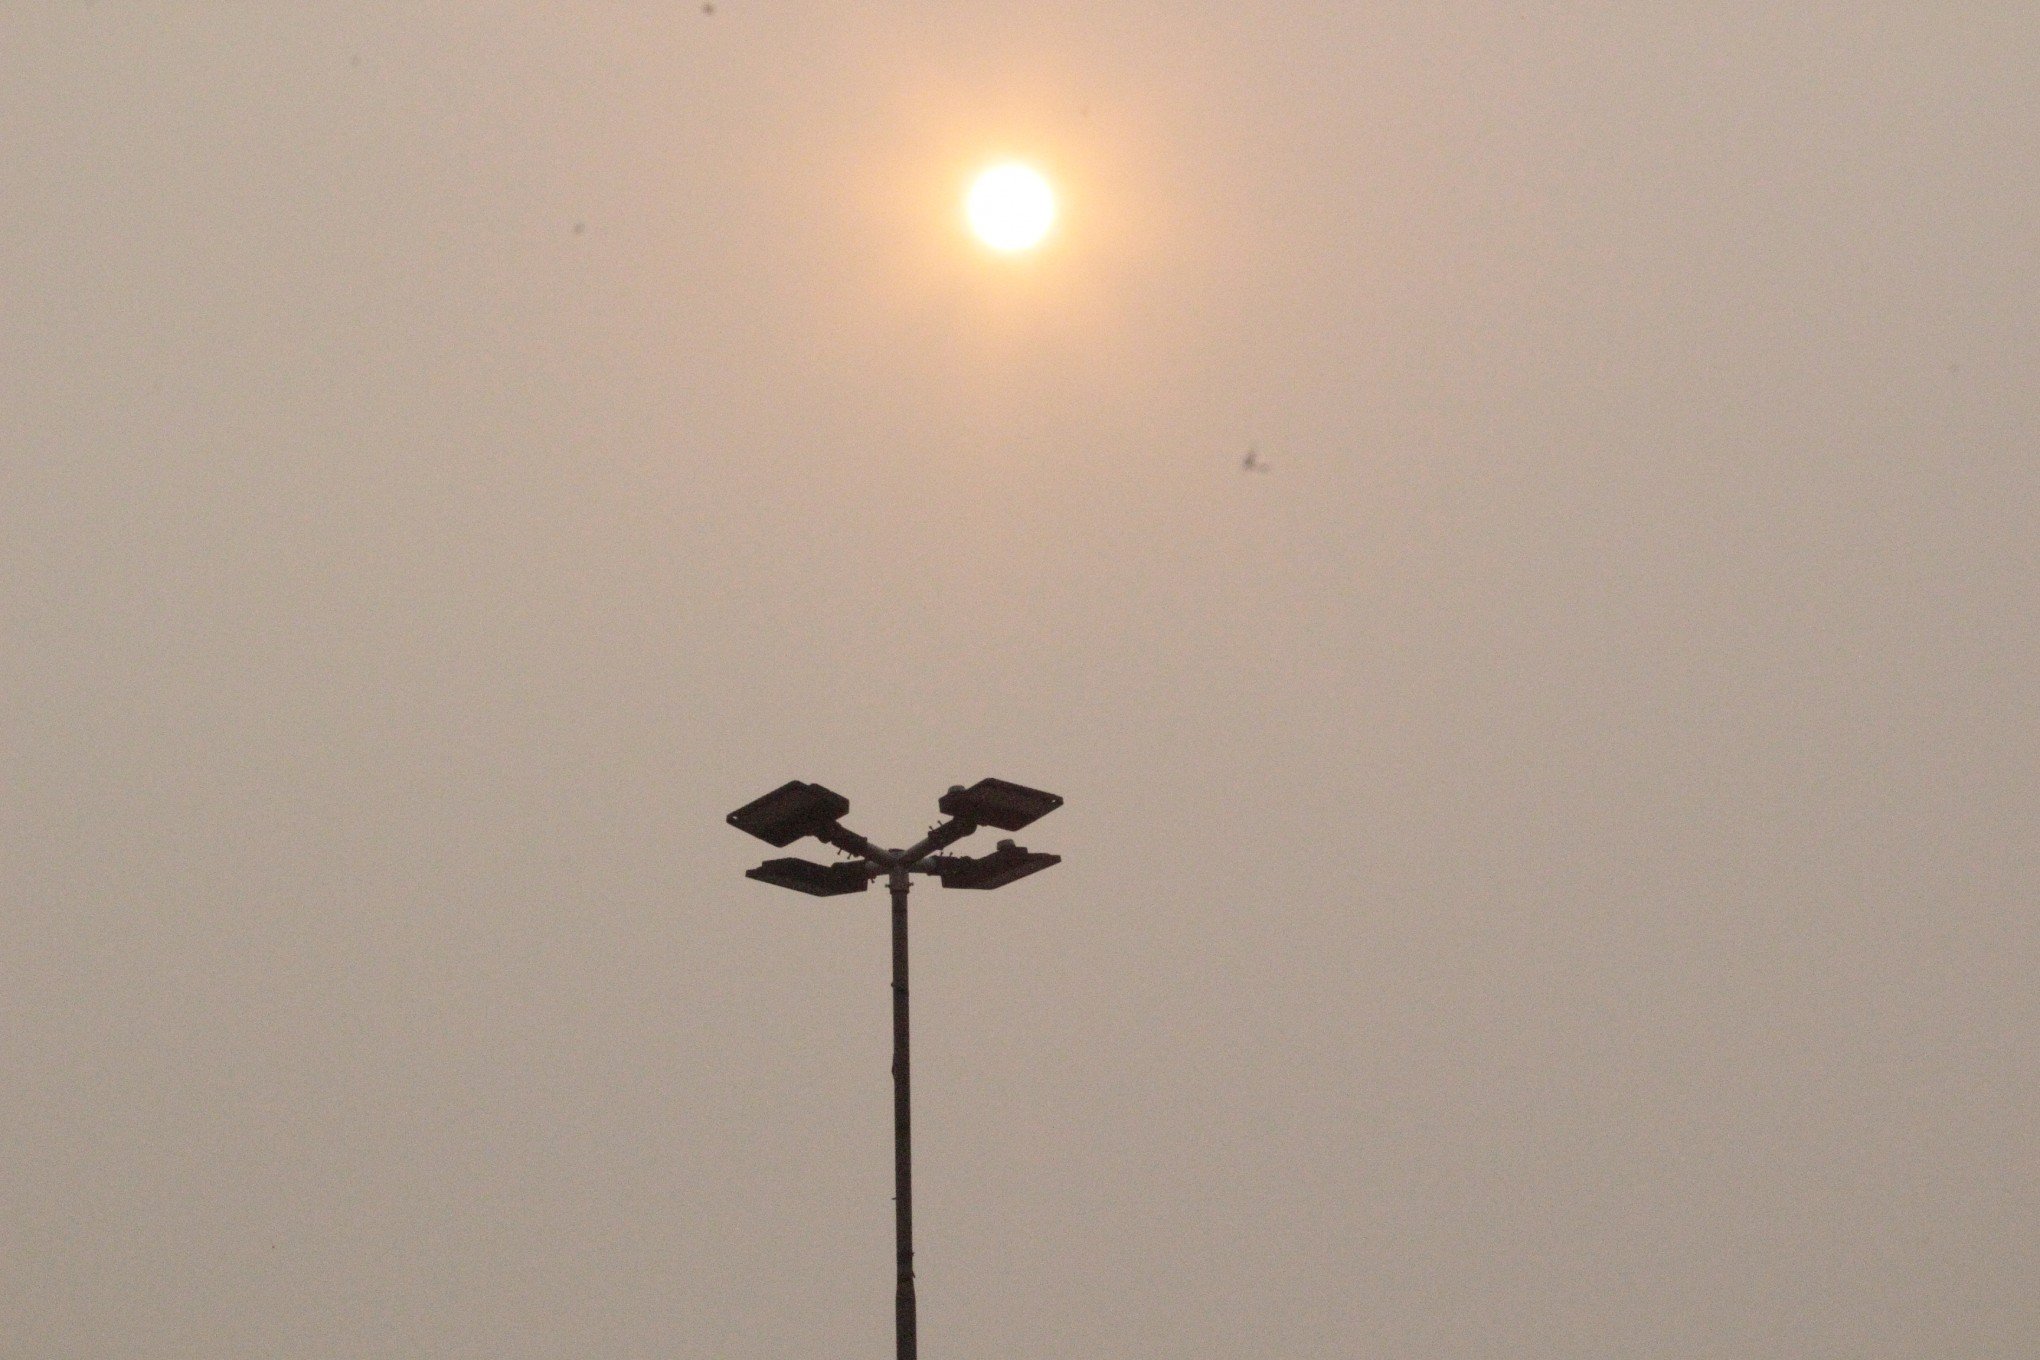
top-left (730, 779), bottom-right (1063, 1360)
